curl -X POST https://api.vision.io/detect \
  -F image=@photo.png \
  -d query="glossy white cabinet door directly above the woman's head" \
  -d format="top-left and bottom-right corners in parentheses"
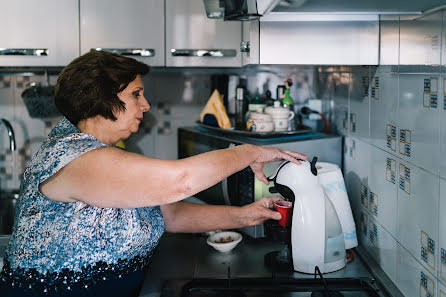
top-left (80, 0), bottom-right (164, 66)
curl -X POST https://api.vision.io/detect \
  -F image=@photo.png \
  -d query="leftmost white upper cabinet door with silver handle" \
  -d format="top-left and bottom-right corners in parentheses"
top-left (0, 0), bottom-right (79, 66)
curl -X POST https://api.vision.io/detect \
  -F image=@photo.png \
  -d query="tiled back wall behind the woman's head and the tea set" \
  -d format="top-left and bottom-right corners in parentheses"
top-left (0, 66), bottom-right (336, 189)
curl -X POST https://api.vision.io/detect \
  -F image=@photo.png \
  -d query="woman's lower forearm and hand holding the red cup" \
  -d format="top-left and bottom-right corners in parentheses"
top-left (161, 197), bottom-right (281, 233)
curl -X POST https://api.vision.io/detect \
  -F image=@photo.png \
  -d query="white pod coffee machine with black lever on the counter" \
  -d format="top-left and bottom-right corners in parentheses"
top-left (269, 157), bottom-right (346, 273)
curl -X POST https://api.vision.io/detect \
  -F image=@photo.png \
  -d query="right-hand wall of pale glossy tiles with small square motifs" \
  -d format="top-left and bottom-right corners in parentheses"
top-left (344, 11), bottom-right (446, 297)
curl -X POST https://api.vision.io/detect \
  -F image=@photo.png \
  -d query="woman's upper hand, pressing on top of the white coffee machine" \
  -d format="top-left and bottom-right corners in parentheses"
top-left (250, 146), bottom-right (307, 184)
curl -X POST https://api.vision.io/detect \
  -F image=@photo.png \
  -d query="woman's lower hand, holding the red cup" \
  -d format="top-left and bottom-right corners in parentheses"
top-left (239, 197), bottom-right (282, 226)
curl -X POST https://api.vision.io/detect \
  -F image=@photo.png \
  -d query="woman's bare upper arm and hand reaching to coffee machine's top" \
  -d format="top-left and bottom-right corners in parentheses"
top-left (40, 145), bottom-right (305, 208)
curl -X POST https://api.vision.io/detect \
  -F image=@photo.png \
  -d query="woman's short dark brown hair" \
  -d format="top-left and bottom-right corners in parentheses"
top-left (54, 50), bottom-right (150, 125)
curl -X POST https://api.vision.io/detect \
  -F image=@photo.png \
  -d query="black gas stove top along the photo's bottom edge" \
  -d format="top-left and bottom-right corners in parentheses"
top-left (161, 278), bottom-right (382, 297)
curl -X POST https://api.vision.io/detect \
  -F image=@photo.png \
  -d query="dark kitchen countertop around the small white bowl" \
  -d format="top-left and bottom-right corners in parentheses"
top-left (140, 234), bottom-right (380, 297)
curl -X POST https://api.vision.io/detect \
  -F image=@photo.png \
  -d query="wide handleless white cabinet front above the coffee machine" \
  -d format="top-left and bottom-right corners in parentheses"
top-left (243, 13), bottom-right (379, 65)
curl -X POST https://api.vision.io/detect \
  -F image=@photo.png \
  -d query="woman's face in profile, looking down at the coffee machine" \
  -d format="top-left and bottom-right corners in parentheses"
top-left (114, 75), bottom-right (150, 139)
